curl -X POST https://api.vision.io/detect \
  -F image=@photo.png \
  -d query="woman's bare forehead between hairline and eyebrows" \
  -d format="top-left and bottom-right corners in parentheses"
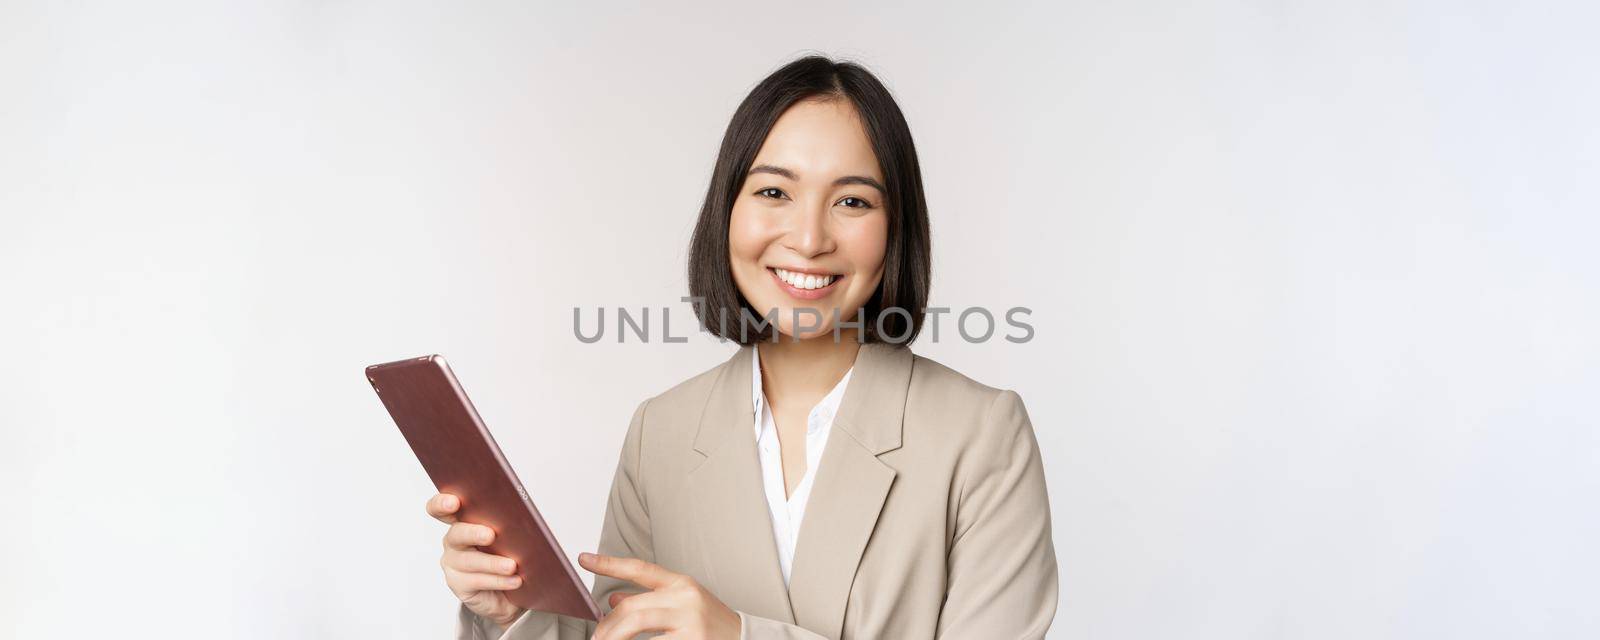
top-left (752, 99), bottom-right (883, 181)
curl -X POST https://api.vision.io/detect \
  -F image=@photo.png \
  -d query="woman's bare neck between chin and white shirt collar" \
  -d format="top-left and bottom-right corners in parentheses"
top-left (755, 330), bottom-right (861, 406)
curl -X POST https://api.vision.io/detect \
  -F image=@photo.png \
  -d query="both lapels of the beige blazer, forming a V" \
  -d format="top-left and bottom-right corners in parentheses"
top-left (690, 342), bottom-right (912, 638)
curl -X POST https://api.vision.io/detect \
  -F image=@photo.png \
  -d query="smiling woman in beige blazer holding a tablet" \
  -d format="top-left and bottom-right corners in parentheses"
top-left (427, 58), bottom-right (1056, 640)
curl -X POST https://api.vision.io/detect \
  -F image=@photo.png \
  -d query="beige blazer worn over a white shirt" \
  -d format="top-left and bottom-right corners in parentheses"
top-left (458, 344), bottom-right (1056, 640)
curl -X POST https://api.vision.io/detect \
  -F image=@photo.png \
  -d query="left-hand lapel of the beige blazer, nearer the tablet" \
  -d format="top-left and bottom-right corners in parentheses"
top-left (690, 347), bottom-right (793, 624)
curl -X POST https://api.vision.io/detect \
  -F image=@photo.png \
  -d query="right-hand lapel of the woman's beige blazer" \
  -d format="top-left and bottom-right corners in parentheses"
top-left (787, 342), bottom-right (912, 638)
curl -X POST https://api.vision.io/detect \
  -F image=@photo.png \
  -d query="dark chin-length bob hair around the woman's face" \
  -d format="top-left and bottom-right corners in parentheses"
top-left (688, 56), bottom-right (933, 344)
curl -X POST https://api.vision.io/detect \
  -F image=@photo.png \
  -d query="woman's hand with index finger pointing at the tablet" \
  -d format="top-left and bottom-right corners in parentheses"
top-left (578, 554), bottom-right (739, 640)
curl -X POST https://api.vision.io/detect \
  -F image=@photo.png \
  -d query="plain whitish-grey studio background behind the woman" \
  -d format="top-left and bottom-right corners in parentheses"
top-left (0, 2), bottom-right (1600, 638)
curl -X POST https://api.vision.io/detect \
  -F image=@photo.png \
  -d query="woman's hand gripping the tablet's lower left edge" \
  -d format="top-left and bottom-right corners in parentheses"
top-left (427, 493), bottom-right (522, 627)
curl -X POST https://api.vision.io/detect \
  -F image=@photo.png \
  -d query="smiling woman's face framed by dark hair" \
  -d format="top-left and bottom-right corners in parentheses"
top-left (728, 99), bottom-right (888, 339)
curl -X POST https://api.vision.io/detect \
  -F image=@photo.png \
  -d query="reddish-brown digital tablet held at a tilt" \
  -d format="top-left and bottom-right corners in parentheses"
top-left (366, 355), bottom-right (600, 621)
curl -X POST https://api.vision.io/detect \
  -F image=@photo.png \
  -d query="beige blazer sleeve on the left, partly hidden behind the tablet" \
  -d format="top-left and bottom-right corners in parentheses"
top-left (456, 400), bottom-right (656, 640)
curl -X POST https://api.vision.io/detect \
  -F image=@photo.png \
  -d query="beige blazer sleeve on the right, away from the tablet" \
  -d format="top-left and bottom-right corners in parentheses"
top-left (936, 390), bottom-right (1058, 638)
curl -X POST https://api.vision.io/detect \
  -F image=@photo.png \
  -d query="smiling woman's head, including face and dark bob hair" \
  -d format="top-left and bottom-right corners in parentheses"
top-left (690, 58), bottom-right (931, 344)
